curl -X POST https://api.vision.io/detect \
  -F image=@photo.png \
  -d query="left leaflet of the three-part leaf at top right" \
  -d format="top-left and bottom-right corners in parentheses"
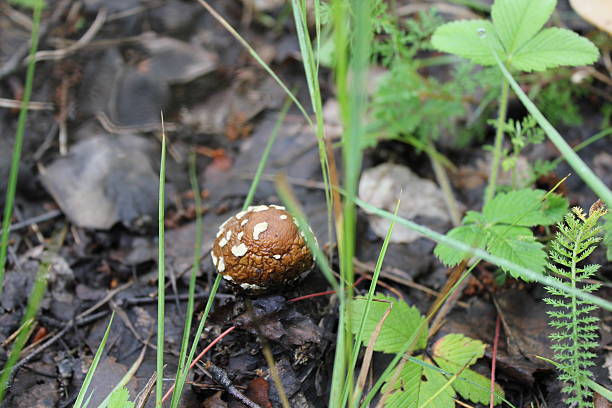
top-left (431, 20), bottom-right (506, 65)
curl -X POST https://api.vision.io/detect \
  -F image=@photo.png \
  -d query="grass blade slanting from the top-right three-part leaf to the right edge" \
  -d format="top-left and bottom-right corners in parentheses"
top-left (492, 52), bottom-right (612, 207)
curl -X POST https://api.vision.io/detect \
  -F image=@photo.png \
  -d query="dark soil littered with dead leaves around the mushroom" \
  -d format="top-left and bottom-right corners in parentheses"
top-left (0, 0), bottom-right (612, 408)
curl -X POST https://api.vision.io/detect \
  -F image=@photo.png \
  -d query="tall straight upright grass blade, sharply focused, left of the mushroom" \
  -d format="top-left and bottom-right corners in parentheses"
top-left (155, 120), bottom-right (166, 407)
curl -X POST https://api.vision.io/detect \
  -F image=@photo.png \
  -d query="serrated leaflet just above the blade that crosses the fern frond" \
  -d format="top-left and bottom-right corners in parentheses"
top-left (487, 225), bottom-right (546, 279)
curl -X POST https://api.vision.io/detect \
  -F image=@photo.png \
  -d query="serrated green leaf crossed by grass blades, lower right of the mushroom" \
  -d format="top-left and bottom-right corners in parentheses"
top-left (351, 294), bottom-right (427, 353)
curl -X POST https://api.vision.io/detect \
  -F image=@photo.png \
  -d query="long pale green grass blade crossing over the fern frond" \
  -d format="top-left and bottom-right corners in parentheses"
top-left (355, 199), bottom-right (612, 310)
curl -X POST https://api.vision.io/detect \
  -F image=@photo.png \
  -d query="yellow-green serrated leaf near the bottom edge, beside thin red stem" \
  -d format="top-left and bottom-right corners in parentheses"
top-left (432, 334), bottom-right (504, 404)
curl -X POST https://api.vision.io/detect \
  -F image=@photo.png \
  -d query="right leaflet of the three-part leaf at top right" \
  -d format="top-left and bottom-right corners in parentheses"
top-left (509, 28), bottom-right (599, 71)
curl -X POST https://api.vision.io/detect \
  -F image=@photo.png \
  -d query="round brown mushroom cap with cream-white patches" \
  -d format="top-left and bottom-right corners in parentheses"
top-left (211, 205), bottom-right (314, 293)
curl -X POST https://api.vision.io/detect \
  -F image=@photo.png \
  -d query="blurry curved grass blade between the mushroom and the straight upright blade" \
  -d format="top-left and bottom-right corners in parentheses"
top-left (170, 152), bottom-right (202, 408)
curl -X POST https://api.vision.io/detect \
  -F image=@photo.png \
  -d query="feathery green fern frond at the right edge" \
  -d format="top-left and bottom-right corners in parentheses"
top-left (544, 202), bottom-right (606, 408)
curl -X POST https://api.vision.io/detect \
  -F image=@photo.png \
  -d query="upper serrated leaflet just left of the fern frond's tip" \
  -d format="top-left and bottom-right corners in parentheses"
top-left (482, 189), bottom-right (567, 227)
